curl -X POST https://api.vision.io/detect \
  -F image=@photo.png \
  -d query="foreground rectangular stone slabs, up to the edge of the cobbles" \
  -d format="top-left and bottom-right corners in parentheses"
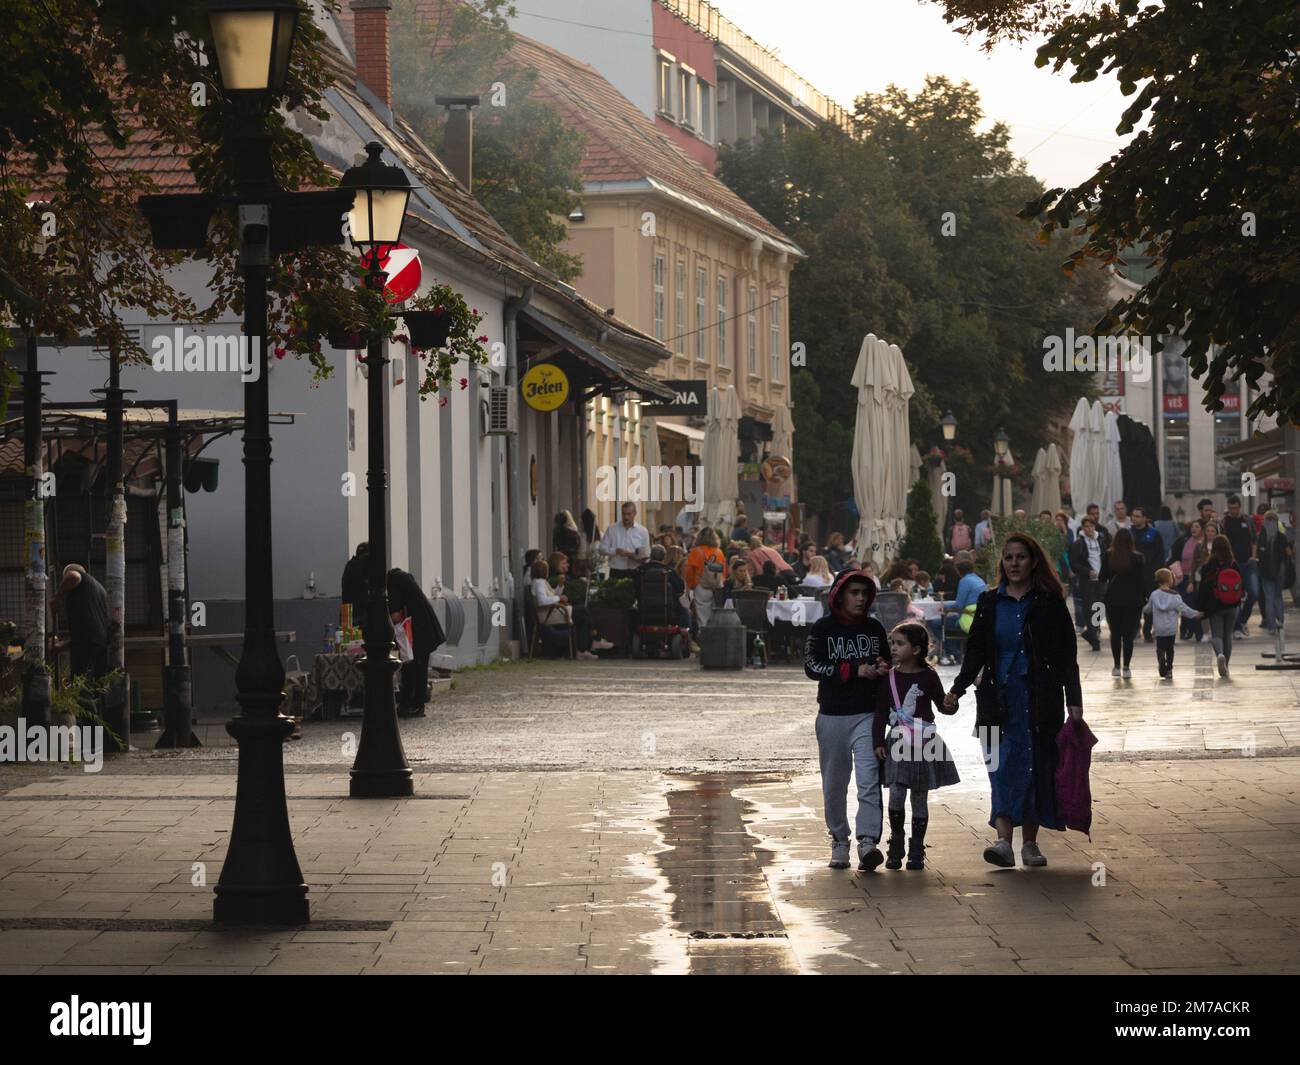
top-left (0, 757), bottom-right (1300, 974)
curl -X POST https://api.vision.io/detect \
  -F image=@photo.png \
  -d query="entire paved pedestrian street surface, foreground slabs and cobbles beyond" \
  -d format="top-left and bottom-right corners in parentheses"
top-left (0, 616), bottom-right (1300, 973)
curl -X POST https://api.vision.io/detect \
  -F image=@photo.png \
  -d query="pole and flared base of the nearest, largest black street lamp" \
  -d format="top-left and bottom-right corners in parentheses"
top-left (212, 222), bottom-right (309, 925)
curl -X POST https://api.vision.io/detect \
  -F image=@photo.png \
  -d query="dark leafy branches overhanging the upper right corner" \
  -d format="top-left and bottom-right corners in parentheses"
top-left (932, 0), bottom-right (1300, 421)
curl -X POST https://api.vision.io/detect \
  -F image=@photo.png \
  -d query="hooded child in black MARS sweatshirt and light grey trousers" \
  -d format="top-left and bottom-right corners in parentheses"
top-left (803, 571), bottom-right (889, 871)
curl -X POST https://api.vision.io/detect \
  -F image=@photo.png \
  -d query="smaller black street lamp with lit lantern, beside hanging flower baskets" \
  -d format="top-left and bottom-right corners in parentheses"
top-left (339, 142), bottom-right (415, 798)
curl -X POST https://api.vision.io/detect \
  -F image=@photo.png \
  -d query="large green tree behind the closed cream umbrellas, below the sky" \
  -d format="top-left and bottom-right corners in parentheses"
top-left (720, 78), bottom-right (1106, 527)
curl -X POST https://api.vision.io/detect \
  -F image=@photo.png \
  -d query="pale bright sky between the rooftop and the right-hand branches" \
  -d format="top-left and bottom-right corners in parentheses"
top-left (711, 0), bottom-right (1126, 187)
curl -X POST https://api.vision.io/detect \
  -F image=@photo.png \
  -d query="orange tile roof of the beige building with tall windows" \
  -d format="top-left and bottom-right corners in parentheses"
top-left (511, 34), bottom-right (793, 243)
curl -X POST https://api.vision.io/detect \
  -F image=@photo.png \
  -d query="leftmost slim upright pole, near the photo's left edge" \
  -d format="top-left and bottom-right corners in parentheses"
top-left (22, 338), bottom-right (51, 728)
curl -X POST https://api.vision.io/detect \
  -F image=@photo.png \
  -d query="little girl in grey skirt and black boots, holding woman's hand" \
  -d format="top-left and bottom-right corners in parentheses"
top-left (871, 622), bottom-right (961, 870)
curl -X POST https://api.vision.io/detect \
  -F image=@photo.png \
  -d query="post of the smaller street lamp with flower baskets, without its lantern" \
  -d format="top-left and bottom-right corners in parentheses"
top-left (348, 258), bottom-right (415, 798)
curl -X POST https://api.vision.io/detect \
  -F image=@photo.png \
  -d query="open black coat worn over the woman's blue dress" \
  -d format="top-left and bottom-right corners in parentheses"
top-left (952, 588), bottom-right (1083, 743)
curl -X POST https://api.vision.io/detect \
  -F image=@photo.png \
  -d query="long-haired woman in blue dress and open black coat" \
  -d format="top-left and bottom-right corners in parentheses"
top-left (945, 533), bottom-right (1083, 867)
